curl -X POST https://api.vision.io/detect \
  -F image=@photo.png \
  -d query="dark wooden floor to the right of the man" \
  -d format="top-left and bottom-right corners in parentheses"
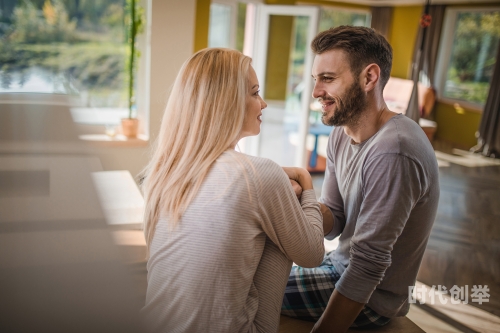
top-left (417, 144), bottom-right (500, 316)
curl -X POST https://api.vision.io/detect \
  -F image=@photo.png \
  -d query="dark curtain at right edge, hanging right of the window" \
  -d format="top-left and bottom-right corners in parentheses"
top-left (471, 43), bottom-right (500, 158)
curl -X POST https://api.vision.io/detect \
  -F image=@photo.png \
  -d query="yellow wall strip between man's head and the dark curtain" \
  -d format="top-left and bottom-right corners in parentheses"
top-left (389, 6), bottom-right (422, 79)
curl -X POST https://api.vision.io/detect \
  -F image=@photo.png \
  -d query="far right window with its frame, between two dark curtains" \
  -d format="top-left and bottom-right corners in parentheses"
top-left (436, 8), bottom-right (500, 107)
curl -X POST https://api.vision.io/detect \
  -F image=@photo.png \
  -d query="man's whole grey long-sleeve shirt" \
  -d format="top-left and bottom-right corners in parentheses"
top-left (320, 114), bottom-right (439, 317)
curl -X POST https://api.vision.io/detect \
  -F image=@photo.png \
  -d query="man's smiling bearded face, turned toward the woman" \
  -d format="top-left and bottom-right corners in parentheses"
top-left (312, 50), bottom-right (367, 127)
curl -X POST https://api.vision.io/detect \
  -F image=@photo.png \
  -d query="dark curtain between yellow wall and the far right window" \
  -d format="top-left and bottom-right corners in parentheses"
top-left (406, 5), bottom-right (446, 123)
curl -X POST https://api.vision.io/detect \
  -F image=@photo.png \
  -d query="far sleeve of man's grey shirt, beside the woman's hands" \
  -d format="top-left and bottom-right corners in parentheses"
top-left (319, 134), bottom-right (346, 240)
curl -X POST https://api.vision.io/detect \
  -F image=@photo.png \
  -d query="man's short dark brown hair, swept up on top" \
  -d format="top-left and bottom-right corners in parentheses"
top-left (311, 25), bottom-right (392, 89)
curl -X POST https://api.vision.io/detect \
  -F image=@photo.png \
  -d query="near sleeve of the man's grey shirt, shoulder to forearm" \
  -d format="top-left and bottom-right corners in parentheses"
top-left (335, 154), bottom-right (422, 303)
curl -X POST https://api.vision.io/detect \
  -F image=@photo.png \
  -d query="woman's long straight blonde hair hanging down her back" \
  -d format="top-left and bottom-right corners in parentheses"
top-left (142, 48), bottom-right (251, 253)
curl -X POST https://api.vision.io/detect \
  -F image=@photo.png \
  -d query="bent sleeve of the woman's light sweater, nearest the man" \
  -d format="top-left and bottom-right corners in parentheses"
top-left (256, 160), bottom-right (325, 267)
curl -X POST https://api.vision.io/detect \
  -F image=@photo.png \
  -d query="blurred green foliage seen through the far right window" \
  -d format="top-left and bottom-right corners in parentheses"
top-left (443, 10), bottom-right (500, 105)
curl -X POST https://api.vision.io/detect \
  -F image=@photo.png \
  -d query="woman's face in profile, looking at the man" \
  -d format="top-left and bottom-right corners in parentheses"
top-left (240, 66), bottom-right (267, 138)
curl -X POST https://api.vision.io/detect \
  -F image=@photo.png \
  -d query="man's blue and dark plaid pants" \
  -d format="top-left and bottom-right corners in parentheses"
top-left (281, 254), bottom-right (390, 328)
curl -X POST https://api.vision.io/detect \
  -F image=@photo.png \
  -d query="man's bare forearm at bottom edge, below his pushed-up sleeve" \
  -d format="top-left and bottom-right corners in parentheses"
top-left (311, 289), bottom-right (364, 333)
